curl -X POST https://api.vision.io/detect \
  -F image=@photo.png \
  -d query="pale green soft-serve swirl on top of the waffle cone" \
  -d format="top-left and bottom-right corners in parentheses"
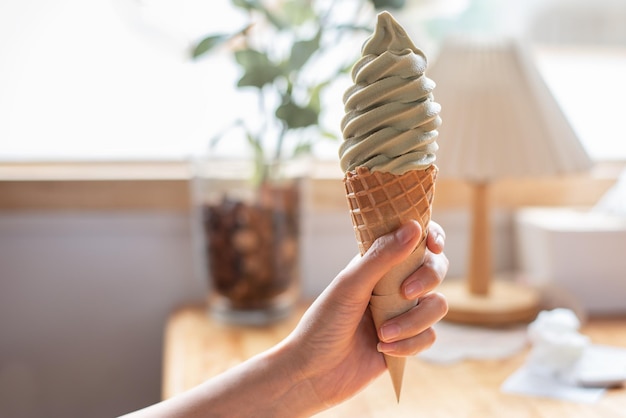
top-left (339, 12), bottom-right (441, 175)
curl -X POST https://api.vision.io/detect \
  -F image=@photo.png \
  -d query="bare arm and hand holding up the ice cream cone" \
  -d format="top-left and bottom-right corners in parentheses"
top-left (120, 223), bottom-right (447, 417)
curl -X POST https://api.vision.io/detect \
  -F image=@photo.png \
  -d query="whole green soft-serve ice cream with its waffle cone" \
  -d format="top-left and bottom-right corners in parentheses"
top-left (339, 12), bottom-right (441, 399)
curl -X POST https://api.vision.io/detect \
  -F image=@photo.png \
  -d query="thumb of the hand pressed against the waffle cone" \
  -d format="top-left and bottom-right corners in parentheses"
top-left (333, 220), bottom-right (422, 302)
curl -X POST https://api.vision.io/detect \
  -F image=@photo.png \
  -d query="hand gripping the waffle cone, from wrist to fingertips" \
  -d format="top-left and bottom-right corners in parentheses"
top-left (284, 222), bottom-right (448, 414)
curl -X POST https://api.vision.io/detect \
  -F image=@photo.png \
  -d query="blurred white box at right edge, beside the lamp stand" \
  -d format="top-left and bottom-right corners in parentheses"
top-left (515, 208), bottom-right (626, 314)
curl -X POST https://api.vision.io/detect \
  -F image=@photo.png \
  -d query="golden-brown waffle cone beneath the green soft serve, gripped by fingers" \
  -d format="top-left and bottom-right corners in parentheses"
top-left (344, 165), bottom-right (437, 400)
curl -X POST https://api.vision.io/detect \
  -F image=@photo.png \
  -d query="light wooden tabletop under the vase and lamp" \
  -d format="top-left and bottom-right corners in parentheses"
top-left (163, 306), bottom-right (626, 418)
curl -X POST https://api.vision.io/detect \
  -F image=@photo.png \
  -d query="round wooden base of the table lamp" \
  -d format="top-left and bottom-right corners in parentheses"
top-left (439, 280), bottom-right (540, 326)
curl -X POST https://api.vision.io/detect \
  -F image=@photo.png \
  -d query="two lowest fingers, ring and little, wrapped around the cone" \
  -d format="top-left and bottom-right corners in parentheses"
top-left (378, 293), bottom-right (448, 356)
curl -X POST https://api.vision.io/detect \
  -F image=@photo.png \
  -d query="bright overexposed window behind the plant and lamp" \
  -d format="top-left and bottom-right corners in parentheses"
top-left (0, 0), bottom-right (626, 161)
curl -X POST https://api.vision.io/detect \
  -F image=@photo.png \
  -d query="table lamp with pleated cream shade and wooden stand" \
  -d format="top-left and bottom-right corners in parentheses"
top-left (428, 39), bottom-right (591, 325)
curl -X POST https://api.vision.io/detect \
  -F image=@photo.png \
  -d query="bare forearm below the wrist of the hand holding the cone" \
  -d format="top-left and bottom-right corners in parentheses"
top-left (120, 344), bottom-right (323, 418)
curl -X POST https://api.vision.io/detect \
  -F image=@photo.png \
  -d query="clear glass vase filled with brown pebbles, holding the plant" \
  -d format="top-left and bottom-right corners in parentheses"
top-left (193, 158), bottom-right (301, 325)
